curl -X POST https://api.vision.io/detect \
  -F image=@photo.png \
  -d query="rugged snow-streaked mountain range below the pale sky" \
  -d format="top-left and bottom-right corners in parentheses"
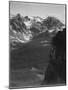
top-left (10, 14), bottom-right (64, 50)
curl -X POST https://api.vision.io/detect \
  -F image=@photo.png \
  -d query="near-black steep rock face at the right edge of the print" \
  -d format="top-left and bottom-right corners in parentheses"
top-left (43, 29), bottom-right (66, 84)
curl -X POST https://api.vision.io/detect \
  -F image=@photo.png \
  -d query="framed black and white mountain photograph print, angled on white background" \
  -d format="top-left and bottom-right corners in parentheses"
top-left (9, 1), bottom-right (66, 89)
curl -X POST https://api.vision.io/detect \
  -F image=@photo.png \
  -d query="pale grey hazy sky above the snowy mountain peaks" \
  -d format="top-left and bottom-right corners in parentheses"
top-left (10, 1), bottom-right (65, 22)
